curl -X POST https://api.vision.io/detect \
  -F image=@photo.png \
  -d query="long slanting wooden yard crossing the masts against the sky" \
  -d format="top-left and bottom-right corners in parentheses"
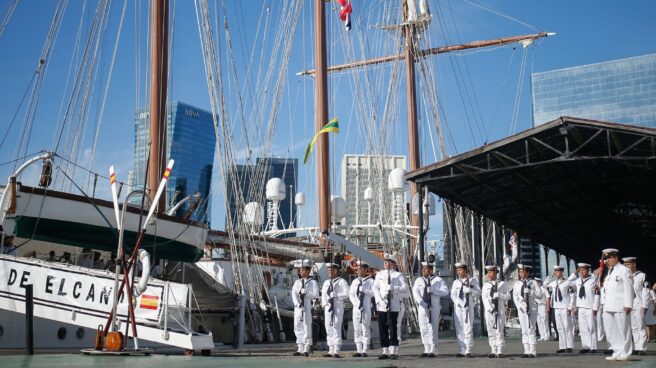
top-left (297, 32), bottom-right (555, 76)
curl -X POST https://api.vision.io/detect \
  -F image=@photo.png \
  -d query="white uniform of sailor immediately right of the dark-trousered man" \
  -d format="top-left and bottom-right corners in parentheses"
top-left (412, 276), bottom-right (449, 354)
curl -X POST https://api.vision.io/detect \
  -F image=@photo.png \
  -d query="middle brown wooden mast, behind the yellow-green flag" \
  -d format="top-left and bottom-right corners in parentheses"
top-left (314, 0), bottom-right (330, 233)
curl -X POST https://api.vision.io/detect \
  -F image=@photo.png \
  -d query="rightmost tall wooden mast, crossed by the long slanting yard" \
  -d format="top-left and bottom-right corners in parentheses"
top-left (403, 0), bottom-right (423, 256)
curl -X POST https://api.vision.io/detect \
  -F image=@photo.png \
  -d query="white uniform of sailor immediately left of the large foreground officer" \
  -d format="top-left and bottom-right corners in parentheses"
top-left (574, 275), bottom-right (600, 350)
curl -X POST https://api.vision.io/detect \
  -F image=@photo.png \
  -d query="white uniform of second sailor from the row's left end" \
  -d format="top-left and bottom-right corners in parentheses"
top-left (321, 277), bottom-right (349, 354)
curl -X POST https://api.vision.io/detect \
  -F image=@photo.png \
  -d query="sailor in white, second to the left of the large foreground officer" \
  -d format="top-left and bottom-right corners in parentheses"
top-left (544, 265), bottom-right (576, 353)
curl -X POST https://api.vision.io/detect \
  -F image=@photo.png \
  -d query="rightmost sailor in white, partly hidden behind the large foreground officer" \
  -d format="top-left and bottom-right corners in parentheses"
top-left (622, 257), bottom-right (649, 355)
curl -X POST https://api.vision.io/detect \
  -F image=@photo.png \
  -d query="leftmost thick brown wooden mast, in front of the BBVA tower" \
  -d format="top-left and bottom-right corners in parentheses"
top-left (147, 0), bottom-right (169, 213)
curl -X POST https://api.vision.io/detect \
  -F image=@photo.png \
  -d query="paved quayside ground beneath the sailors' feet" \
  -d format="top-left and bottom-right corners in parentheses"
top-left (0, 338), bottom-right (656, 368)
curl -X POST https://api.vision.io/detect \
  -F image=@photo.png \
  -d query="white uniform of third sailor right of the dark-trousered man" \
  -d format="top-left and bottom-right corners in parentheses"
top-left (481, 280), bottom-right (510, 354)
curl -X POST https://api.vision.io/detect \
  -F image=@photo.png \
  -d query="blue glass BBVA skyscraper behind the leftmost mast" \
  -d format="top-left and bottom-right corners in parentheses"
top-left (132, 102), bottom-right (215, 221)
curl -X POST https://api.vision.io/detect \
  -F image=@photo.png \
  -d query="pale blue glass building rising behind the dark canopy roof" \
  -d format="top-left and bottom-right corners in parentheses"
top-left (531, 54), bottom-right (656, 127)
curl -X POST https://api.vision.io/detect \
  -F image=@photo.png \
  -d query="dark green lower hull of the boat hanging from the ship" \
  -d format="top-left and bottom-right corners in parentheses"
top-left (15, 216), bottom-right (203, 262)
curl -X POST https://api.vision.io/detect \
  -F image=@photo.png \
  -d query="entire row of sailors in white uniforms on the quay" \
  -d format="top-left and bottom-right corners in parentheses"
top-left (292, 249), bottom-right (648, 360)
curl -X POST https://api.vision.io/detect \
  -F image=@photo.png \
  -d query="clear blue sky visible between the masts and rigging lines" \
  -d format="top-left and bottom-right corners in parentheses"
top-left (0, 0), bottom-right (656, 244)
